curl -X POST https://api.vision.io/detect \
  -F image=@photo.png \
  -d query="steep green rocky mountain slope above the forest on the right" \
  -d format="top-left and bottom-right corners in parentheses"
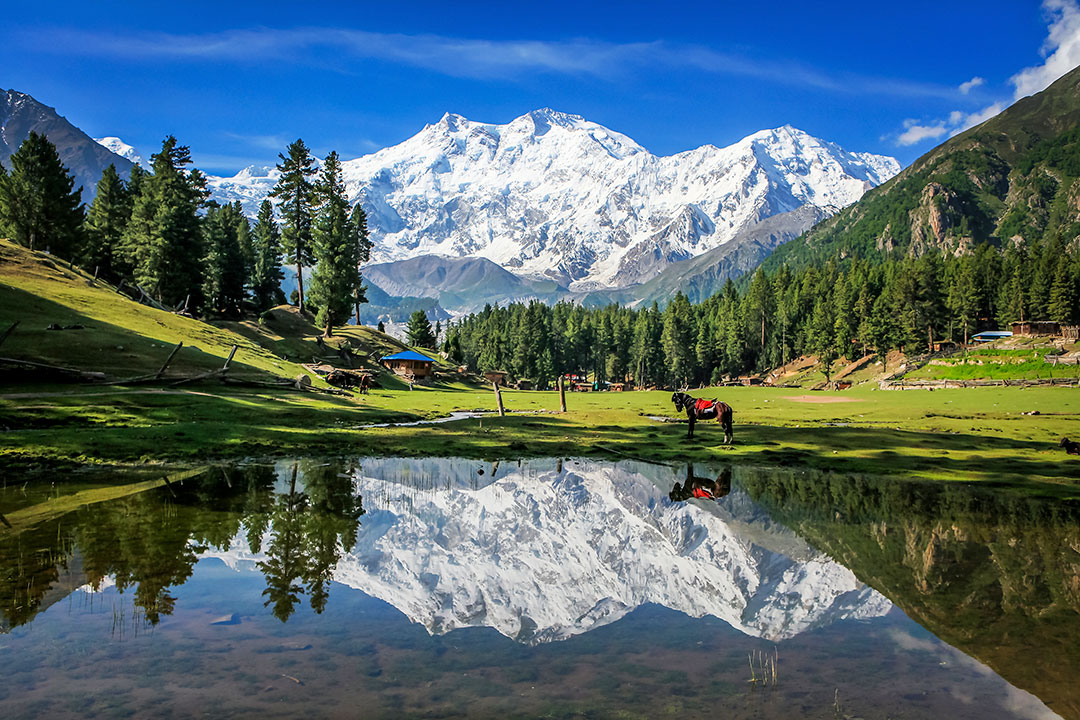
top-left (766, 63), bottom-right (1080, 276)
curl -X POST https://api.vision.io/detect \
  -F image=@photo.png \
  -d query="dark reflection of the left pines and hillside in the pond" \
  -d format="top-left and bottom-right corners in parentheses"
top-left (0, 461), bottom-right (364, 630)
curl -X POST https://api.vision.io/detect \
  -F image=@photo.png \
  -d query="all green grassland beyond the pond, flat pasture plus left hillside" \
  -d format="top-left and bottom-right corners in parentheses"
top-left (0, 242), bottom-right (1080, 498)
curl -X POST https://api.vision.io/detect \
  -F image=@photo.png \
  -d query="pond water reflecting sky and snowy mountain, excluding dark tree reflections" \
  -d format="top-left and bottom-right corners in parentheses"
top-left (0, 459), bottom-right (1056, 720)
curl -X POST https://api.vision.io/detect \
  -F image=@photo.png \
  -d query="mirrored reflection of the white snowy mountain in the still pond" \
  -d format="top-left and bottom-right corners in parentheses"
top-left (206, 459), bottom-right (891, 643)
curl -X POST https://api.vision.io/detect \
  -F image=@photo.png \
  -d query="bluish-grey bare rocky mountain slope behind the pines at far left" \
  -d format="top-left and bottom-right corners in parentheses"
top-left (0, 90), bottom-right (133, 204)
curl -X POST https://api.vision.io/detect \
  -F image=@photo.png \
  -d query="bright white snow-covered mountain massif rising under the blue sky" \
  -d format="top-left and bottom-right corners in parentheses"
top-left (212, 108), bottom-right (900, 290)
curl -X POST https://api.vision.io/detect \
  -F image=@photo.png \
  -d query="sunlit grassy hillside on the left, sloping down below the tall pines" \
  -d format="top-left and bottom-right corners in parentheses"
top-left (0, 240), bottom-right (453, 388)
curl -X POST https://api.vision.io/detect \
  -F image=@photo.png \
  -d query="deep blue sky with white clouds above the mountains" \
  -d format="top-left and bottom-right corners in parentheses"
top-left (0, 0), bottom-right (1080, 174)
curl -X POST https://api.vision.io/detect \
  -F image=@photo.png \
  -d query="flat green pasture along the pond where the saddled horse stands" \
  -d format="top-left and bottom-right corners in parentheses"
top-left (0, 385), bottom-right (1080, 497)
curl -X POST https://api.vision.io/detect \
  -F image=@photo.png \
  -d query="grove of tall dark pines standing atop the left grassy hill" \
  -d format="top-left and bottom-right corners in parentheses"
top-left (0, 132), bottom-right (372, 335)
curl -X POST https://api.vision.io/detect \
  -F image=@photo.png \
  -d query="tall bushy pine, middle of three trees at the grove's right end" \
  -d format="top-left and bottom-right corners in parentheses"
top-left (311, 152), bottom-right (360, 338)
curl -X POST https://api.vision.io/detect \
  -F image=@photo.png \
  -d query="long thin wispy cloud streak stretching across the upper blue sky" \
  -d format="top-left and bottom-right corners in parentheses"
top-left (19, 27), bottom-right (956, 97)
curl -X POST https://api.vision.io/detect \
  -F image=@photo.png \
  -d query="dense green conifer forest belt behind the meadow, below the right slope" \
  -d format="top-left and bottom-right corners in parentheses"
top-left (442, 242), bottom-right (1080, 386)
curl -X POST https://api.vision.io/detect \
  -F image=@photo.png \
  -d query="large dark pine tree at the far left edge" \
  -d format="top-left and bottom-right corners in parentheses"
top-left (0, 131), bottom-right (85, 259)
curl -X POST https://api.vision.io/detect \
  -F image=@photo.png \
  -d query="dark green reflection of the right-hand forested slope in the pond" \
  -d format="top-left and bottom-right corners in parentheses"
top-left (740, 471), bottom-right (1080, 717)
